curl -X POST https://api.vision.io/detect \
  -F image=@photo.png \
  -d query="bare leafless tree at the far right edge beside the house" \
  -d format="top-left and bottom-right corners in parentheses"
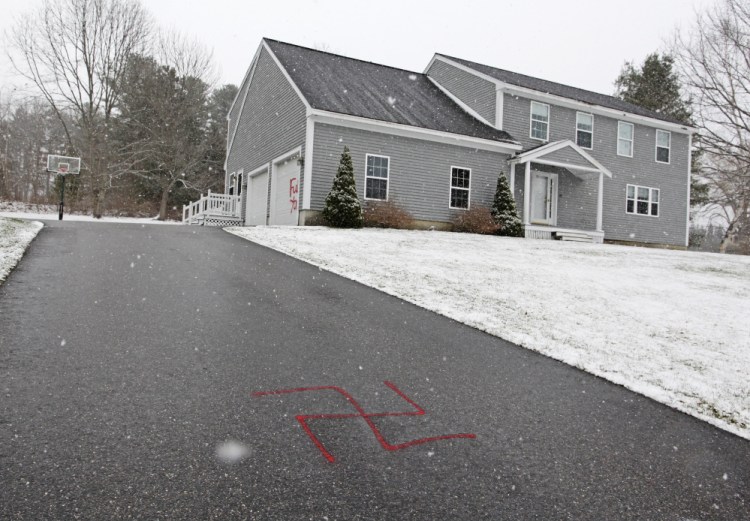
top-left (673, 0), bottom-right (750, 251)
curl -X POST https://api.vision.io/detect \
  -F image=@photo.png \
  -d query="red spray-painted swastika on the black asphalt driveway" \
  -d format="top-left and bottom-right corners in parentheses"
top-left (253, 382), bottom-right (477, 463)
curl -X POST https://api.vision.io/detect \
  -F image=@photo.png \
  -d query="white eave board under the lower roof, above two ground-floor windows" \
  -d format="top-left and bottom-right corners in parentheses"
top-left (309, 109), bottom-right (522, 154)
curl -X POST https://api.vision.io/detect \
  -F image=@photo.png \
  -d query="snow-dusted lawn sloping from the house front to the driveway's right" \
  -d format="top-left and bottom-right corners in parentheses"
top-left (227, 227), bottom-right (750, 439)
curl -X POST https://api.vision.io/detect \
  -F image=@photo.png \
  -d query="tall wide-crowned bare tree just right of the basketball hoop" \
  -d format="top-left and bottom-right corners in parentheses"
top-left (9, 0), bottom-right (151, 217)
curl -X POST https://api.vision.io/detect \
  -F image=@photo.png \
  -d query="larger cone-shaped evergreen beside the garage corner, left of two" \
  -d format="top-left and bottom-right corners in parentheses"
top-left (323, 146), bottom-right (364, 228)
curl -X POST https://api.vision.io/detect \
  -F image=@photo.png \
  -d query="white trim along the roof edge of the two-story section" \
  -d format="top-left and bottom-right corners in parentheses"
top-left (425, 53), bottom-right (698, 134)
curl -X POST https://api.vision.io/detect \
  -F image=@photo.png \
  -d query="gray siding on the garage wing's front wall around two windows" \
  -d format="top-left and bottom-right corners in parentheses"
top-left (308, 123), bottom-right (508, 222)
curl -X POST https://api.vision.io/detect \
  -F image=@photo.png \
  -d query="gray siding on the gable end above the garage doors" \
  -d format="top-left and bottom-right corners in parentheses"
top-left (227, 49), bottom-right (306, 219)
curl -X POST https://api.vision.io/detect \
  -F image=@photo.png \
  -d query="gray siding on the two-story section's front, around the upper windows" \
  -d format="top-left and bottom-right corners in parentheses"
top-left (503, 93), bottom-right (690, 246)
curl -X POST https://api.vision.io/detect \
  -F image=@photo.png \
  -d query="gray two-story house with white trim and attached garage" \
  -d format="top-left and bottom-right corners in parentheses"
top-left (194, 39), bottom-right (694, 246)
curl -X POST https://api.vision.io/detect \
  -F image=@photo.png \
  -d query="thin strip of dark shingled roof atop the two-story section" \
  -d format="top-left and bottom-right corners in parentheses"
top-left (438, 53), bottom-right (684, 125)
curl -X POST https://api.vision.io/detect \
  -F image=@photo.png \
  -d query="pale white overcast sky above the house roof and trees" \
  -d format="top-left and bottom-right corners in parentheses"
top-left (0, 0), bottom-right (716, 99)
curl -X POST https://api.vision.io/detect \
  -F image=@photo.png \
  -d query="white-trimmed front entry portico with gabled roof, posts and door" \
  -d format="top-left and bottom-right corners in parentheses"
top-left (509, 140), bottom-right (612, 242)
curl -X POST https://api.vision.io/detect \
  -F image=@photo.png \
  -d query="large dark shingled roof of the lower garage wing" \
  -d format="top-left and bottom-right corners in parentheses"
top-left (265, 38), bottom-right (516, 143)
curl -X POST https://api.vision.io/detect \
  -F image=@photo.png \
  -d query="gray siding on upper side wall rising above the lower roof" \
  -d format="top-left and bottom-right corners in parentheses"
top-left (427, 60), bottom-right (496, 125)
